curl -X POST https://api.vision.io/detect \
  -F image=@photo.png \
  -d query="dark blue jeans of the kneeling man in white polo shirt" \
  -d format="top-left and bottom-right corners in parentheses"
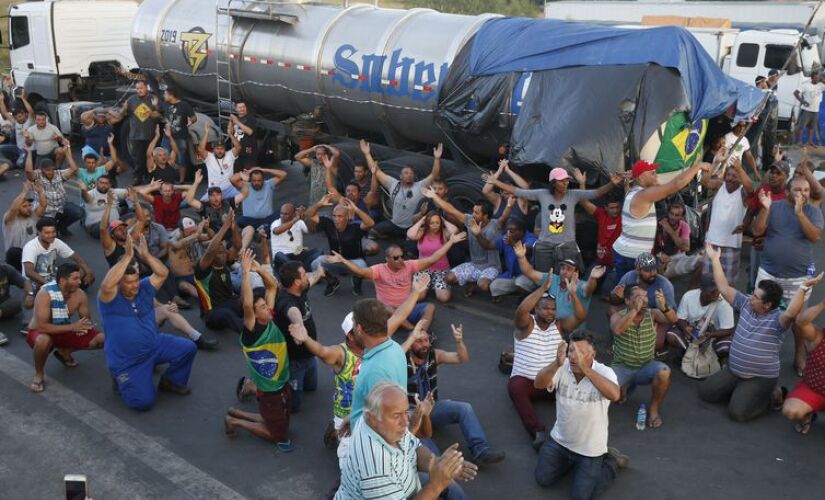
top-left (535, 437), bottom-right (616, 500)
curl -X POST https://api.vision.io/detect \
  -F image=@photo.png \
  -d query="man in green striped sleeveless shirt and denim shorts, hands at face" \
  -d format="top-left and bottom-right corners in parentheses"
top-left (610, 286), bottom-right (677, 429)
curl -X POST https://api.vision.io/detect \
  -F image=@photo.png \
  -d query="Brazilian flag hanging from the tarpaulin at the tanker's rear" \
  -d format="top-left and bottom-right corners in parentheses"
top-left (656, 113), bottom-right (708, 173)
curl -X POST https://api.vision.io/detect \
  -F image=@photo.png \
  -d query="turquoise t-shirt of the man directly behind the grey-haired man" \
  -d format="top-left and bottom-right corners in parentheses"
top-left (349, 339), bottom-right (407, 428)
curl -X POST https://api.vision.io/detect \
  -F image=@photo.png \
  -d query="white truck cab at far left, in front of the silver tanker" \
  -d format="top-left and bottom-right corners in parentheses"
top-left (8, 0), bottom-right (138, 103)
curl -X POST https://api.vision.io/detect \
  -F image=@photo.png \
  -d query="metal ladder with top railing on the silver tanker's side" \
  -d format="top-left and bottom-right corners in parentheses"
top-left (215, 0), bottom-right (302, 131)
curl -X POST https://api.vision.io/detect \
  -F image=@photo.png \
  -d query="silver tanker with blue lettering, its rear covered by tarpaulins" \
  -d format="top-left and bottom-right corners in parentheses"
top-left (3, 0), bottom-right (763, 197)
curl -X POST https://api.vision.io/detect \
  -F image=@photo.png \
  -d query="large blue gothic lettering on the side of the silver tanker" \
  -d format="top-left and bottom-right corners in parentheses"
top-left (333, 44), bottom-right (449, 102)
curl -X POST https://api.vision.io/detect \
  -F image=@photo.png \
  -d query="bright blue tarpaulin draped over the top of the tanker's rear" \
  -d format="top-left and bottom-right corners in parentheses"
top-left (469, 18), bottom-right (762, 120)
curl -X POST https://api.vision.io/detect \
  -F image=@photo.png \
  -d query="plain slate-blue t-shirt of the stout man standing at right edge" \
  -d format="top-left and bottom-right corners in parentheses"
top-left (760, 200), bottom-right (825, 278)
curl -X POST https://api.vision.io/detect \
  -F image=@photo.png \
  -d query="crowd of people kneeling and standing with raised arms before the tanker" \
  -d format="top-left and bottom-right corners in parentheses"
top-left (0, 67), bottom-right (825, 499)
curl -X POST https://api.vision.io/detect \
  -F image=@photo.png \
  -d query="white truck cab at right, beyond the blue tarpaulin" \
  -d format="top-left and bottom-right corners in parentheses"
top-left (722, 30), bottom-right (822, 127)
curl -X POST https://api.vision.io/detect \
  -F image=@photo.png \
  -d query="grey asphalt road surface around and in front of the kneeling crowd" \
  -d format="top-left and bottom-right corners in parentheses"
top-left (0, 153), bottom-right (825, 500)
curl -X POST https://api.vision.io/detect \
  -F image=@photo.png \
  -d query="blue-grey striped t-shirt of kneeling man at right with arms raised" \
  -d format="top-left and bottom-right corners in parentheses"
top-left (728, 292), bottom-right (786, 378)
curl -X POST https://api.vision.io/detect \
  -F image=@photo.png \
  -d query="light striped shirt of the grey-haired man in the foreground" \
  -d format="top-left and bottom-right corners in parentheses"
top-left (335, 419), bottom-right (421, 500)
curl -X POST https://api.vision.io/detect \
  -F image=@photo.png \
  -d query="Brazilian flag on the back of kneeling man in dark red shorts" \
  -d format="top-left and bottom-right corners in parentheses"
top-left (239, 321), bottom-right (289, 392)
